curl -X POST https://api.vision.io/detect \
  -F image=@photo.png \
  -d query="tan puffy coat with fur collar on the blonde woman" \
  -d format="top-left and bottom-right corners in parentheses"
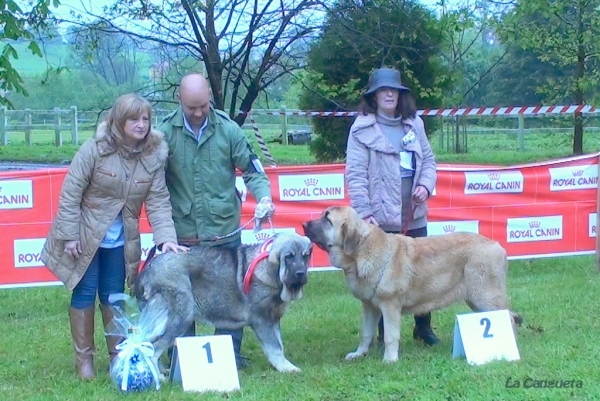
top-left (42, 123), bottom-right (177, 290)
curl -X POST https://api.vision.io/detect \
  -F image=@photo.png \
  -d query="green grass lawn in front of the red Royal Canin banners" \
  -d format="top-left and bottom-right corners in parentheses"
top-left (0, 256), bottom-right (600, 401)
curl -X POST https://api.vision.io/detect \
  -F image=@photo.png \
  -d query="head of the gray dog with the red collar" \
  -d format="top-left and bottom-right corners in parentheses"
top-left (269, 234), bottom-right (312, 302)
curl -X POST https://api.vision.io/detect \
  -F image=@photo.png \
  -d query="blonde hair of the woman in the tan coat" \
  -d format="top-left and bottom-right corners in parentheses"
top-left (106, 93), bottom-right (152, 147)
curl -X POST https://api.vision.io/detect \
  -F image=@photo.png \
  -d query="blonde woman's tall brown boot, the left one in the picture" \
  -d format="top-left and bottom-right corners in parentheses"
top-left (69, 306), bottom-right (96, 380)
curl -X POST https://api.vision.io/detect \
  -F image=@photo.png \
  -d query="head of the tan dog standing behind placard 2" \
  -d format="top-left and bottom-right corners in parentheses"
top-left (302, 206), bottom-right (369, 260)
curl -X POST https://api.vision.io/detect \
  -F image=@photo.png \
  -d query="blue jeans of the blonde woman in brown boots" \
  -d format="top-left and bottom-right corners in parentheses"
top-left (71, 246), bottom-right (125, 309)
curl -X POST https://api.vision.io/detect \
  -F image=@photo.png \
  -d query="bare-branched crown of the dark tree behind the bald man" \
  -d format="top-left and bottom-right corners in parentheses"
top-left (72, 0), bottom-right (323, 124)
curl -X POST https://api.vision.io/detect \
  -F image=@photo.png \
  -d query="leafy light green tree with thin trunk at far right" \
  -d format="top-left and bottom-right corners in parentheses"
top-left (501, 0), bottom-right (600, 154)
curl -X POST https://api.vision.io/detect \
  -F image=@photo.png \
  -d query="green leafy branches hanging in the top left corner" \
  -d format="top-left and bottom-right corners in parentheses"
top-left (0, 0), bottom-right (59, 107)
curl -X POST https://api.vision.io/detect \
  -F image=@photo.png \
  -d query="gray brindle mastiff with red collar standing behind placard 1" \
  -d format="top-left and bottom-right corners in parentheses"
top-left (134, 234), bottom-right (312, 372)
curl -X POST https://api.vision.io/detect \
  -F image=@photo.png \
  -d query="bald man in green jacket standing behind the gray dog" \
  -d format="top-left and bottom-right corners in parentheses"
top-left (157, 74), bottom-right (274, 368)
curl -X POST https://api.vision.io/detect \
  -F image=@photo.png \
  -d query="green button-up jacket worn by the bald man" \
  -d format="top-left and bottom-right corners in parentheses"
top-left (157, 106), bottom-right (271, 245)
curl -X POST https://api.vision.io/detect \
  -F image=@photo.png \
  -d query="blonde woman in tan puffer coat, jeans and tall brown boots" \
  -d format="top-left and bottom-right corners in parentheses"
top-left (42, 94), bottom-right (187, 379)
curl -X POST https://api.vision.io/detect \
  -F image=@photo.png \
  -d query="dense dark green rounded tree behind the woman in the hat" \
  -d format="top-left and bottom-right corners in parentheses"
top-left (300, 0), bottom-right (449, 162)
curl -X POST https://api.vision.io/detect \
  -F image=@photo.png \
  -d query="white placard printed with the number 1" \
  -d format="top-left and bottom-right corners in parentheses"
top-left (170, 335), bottom-right (240, 392)
